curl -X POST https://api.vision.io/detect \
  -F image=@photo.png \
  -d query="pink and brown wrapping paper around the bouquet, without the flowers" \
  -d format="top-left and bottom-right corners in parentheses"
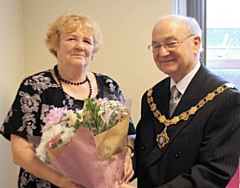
top-left (49, 118), bottom-right (129, 188)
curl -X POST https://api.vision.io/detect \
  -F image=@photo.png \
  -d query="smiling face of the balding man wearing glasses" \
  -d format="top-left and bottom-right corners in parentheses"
top-left (152, 17), bottom-right (201, 82)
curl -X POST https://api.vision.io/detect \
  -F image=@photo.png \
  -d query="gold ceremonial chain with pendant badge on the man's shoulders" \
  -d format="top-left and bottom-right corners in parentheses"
top-left (147, 83), bottom-right (234, 149)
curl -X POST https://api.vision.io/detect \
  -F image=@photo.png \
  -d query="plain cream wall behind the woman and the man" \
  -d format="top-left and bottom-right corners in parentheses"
top-left (0, 0), bottom-right (172, 188)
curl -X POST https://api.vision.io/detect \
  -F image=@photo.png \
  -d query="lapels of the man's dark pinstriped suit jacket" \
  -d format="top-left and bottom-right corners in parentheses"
top-left (144, 66), bottom-right (207, 169)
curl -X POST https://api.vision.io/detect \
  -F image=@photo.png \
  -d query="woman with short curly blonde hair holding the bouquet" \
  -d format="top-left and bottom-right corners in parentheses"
top-left (0, 12), bottom-right (135, 188)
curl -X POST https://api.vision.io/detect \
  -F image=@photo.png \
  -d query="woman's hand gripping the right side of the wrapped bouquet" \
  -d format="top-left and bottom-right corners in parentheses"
top-left (123, 149), bottom-right (134, 183)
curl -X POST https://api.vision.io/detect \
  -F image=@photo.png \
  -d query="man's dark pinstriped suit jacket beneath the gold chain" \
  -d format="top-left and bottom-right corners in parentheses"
top-left (133, 65), bottom-right (240, 188)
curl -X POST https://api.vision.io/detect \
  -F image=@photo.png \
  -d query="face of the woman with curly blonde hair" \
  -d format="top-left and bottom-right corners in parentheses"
top-left (56, 28), bottom-right (94, 68)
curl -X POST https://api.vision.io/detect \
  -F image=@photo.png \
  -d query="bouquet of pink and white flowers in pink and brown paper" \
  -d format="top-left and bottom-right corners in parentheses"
top-left (36, 98), bottom-right (130, 188)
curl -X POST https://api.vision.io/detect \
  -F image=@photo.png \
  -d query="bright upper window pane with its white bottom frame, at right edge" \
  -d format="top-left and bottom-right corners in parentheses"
top-left (206, 0), bottom-right (240, 68)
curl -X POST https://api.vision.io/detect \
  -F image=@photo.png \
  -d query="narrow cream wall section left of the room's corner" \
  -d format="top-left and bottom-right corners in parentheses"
top-left (0, 0), bottom-right (24, 188)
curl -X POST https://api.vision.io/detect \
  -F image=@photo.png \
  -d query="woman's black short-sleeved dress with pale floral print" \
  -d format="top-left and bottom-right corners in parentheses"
top-left (0, 70), bottom-right (135, 188)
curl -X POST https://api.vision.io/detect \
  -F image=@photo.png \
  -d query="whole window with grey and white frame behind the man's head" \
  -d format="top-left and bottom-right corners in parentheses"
top-left (173, 0), bottom-right (240, 90)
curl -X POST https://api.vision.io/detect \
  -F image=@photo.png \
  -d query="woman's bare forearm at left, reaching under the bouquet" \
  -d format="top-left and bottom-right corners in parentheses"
top-left (11, 134), bottom-right (79, 188)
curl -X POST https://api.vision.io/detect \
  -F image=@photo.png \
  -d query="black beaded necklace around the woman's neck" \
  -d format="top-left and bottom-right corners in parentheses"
top-left (54, 65), bottom-right (92, 98)
